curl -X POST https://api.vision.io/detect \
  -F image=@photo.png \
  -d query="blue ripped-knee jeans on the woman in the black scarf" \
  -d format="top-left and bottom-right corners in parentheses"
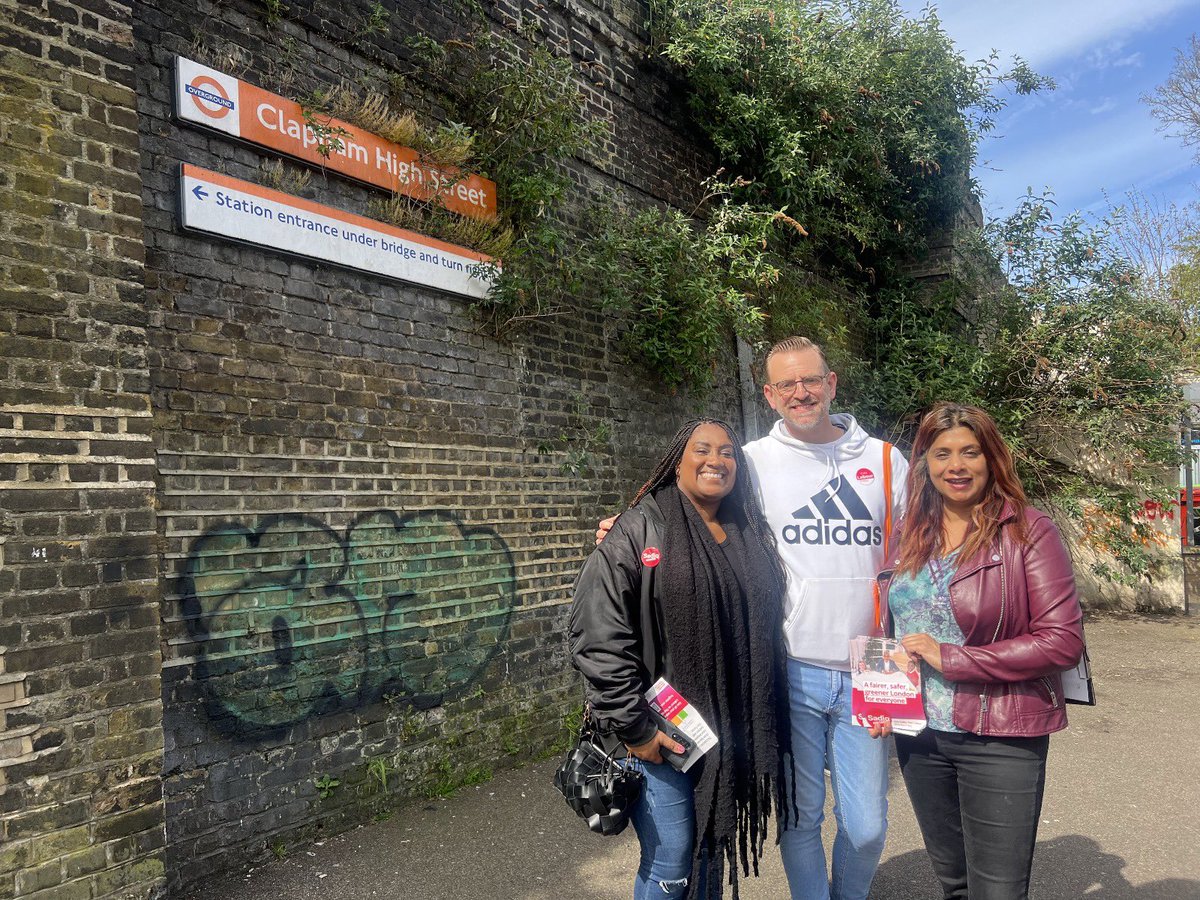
top-left (629, 761), bottom-right (696, 900)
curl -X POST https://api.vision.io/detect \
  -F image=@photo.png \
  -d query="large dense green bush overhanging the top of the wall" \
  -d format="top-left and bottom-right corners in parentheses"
top-left (652, 0), bottom-right (1046, 282)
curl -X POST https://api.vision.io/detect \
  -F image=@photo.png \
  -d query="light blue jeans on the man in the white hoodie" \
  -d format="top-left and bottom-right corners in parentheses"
top-left (779, 659), bottom-right (888, 900)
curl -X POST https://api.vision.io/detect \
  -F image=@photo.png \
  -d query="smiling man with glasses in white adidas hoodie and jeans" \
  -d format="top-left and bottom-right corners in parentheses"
top-left (744, 337), bottom-right (908, 900)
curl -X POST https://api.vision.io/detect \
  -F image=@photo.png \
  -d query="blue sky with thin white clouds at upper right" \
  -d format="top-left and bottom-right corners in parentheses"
top-left (901, 0), bottom-right (1200, 222)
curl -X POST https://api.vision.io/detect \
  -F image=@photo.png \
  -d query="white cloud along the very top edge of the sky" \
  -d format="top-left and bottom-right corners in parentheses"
top-left (902, 0), bottom-right (1200, 68)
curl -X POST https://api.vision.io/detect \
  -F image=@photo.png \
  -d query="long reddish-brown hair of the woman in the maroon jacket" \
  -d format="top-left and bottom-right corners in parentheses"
top-left (896, 403), bottom-right (1028, 575)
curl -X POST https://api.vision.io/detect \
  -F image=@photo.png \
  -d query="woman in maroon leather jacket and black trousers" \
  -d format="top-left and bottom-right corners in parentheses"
top-left (872, 403), bottom-right (1084, 900)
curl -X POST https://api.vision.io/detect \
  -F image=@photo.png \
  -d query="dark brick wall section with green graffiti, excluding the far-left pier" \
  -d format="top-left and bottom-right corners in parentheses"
top-left (134, 0), bottom-right (738, 888)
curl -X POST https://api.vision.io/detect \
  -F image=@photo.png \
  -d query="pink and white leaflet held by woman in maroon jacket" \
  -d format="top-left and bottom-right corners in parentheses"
top-left (850, 636), bottom-right (925, 734)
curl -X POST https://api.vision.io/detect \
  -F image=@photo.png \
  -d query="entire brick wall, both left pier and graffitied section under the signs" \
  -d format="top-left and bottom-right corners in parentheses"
top-left (0, 0), bottom-right (979, 900)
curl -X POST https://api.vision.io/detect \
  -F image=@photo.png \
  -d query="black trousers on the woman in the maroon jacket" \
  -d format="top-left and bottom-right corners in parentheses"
top-left (896, 728), bottom-right (1050, 900)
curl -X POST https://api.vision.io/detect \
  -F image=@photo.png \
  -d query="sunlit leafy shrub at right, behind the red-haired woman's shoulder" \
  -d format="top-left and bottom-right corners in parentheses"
top-left (986, 197), bottom-right (1183, 502)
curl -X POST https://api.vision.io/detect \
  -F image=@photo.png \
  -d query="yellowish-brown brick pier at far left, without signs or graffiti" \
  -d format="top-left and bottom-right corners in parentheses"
top-left (0, 0), bottom-right (164, 899)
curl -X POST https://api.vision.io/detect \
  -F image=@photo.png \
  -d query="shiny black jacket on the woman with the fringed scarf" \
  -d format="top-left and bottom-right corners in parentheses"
top-left (568, 497), bottom-right (671, 749)
